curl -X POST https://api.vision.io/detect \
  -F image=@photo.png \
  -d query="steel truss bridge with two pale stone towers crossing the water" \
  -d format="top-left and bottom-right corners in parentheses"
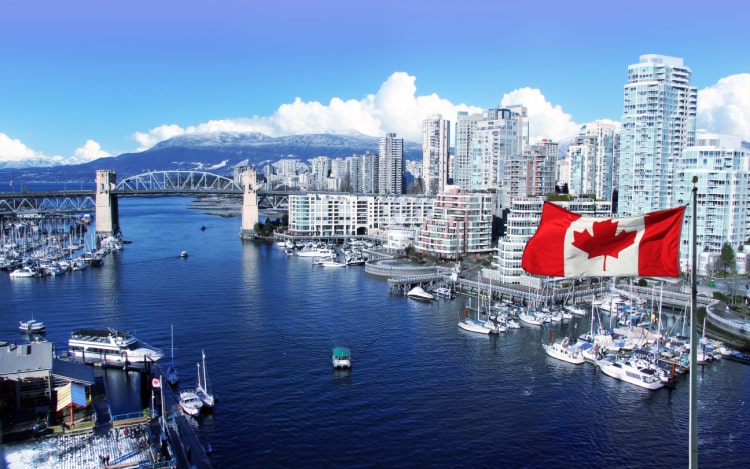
top-left (0, 168), bottom-right (270, 240)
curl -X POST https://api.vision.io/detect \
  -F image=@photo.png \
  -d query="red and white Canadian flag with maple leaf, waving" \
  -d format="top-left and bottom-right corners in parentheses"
top-left (521, 202), bottom-right (685, 277)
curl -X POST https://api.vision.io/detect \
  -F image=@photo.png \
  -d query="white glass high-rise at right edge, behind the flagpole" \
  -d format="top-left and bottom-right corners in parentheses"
top-left (675, 134), bottom-right (750, 275)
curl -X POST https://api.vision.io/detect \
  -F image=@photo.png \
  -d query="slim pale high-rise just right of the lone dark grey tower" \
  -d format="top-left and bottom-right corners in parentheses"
top-left (422, 114), bottom-right (450, 195)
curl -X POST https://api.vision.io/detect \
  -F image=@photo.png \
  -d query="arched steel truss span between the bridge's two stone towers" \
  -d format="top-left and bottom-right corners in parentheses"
top-left (112, 171), bottom-right (242, 195)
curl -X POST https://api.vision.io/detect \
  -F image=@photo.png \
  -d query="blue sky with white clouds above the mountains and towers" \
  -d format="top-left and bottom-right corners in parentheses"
top-left (0, 0), bottom-right (750, 165)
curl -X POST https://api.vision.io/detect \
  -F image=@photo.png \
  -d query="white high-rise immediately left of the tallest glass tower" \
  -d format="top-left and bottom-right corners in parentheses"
top-left (557, 122), bottom-right (620, 200)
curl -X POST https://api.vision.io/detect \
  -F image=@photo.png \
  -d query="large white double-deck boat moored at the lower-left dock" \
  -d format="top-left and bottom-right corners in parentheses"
top-left (68, 328), bottom-right (163, 368)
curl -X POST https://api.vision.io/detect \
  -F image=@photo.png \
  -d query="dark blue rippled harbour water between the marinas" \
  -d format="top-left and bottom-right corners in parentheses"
top-left (0, 198), bottom-right (750, 468)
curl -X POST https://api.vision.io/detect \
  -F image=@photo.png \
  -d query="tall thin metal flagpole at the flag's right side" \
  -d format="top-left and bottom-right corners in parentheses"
top-left (689, 176), bottom-right (698, 469)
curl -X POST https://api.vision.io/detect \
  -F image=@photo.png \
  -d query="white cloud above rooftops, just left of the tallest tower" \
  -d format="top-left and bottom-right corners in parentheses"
top-left (500, 87), bottom-right (581, 144)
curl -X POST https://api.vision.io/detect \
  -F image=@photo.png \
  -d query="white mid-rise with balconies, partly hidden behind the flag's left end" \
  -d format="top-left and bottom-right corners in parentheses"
top-left (490, 197), bottom-right (612, 288)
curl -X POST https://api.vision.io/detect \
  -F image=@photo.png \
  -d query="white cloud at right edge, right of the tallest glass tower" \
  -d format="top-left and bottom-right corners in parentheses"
top-left (696, 73), bottom-right (750, 141)
